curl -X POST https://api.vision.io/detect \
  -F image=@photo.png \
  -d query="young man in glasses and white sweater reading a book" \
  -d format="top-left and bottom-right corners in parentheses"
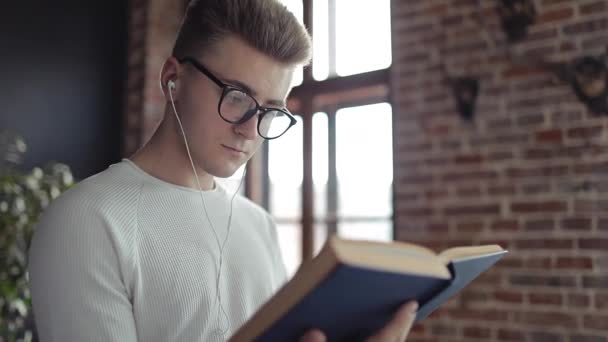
top-left (30, 0), bottom-right (415, 342)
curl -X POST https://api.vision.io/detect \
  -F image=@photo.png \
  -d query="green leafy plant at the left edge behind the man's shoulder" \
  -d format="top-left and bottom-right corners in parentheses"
top-left (0, 132), bottom-right (74, 342)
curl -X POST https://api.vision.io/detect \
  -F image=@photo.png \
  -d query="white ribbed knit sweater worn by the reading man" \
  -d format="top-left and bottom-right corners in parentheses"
top-left (29, 159), bottom-right (287, 342)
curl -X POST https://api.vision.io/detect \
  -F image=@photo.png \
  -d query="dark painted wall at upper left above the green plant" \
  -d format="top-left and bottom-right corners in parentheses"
top-left (0, 0), bottom-right (128, 178)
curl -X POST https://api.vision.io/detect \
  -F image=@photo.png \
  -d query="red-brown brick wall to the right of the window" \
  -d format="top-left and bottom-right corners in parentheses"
top-left (392, 0), bottom-right (608, 342)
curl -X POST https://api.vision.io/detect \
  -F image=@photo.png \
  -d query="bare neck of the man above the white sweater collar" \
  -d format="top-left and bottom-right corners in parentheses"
top-left (129, 120), bottom-right (215, 190)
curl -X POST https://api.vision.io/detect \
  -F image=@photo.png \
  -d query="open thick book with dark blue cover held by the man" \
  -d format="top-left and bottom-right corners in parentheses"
top-left (230, 237), bottom-right (507, 342)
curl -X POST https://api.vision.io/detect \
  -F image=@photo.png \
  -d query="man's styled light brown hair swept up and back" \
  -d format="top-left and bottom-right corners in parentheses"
top-left (173, 0), bottom-right (312, 65)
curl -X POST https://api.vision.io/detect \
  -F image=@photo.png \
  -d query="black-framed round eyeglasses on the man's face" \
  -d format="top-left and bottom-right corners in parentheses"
top-left (178, 57), bottom-right (297, 140)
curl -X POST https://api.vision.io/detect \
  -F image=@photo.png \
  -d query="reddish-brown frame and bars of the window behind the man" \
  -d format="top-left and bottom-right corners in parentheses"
top-left (246, 0), bottom-right (395, 261)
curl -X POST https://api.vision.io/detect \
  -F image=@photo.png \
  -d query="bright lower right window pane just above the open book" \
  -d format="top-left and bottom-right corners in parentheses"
top-left (336, 103), bottom-right (393, 241)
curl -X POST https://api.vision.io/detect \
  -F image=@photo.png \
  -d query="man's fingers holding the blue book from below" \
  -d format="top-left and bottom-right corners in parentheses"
top-left (300, 302), bottom-right (418, 342)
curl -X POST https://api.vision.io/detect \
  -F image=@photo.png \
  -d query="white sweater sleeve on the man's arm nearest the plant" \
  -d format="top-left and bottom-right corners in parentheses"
top-left (29, 198), bottom-right (137, 342)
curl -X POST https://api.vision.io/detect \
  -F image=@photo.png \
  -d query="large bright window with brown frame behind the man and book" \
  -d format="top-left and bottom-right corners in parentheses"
top-left (261, 0), bottom-right (393, 274)
